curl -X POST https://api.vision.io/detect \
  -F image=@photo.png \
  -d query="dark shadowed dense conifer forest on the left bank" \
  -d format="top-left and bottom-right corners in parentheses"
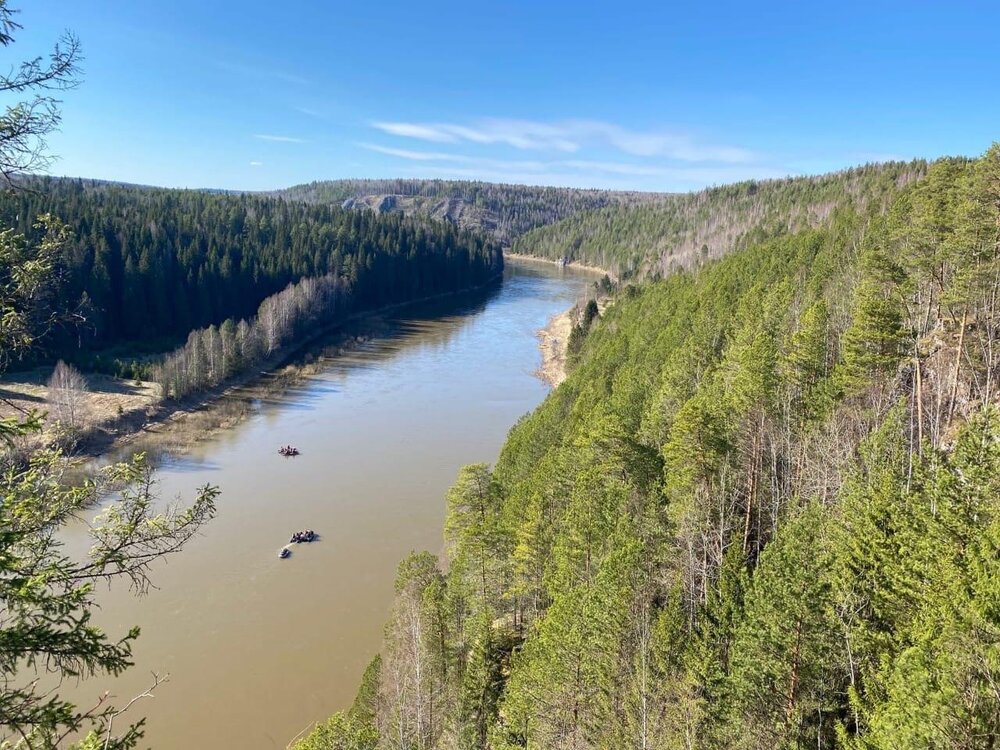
top-left (0, 179), bottom-right (502, 362)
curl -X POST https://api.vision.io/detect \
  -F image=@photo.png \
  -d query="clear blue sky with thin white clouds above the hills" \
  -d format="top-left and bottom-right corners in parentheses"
top-left (4, 0), bottom-right (1000, 190)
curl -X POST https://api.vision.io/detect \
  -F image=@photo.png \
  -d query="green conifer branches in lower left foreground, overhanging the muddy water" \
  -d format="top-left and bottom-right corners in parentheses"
top-left (0, 451), bottom-right (218, 747)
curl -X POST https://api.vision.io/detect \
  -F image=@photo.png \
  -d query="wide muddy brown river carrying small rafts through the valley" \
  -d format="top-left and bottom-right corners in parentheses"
top-left (52, 263), bottom-right (595, 750)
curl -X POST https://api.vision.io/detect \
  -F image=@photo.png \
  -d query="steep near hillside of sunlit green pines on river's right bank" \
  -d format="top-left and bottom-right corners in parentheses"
top-left (299, 145), bottom-right (1000, 750)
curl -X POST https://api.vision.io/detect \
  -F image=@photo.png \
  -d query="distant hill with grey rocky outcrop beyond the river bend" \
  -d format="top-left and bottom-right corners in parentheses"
top-left (277, 180), bottom-right (664, 245)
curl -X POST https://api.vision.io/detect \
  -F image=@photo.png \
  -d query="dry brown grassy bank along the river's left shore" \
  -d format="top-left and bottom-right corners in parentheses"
top-left (0, 272), bottom-right (502, 461)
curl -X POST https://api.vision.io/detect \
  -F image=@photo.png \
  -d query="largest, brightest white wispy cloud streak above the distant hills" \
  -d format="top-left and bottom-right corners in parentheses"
top-left (372, 118), bottom-right (757, 164)
